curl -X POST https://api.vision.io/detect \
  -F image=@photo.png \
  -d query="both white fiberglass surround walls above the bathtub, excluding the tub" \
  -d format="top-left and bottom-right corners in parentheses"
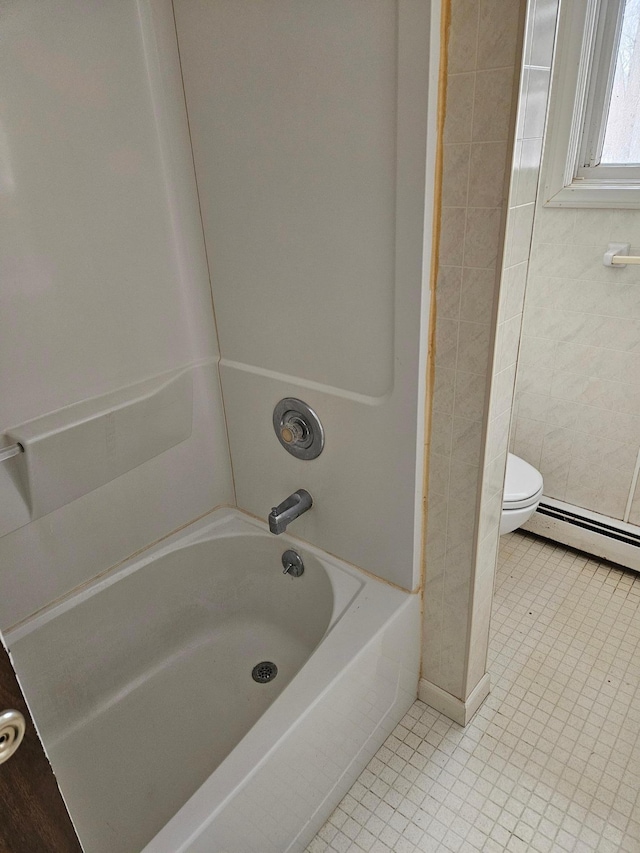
top-left (0, 0), bottom-right (437, 628)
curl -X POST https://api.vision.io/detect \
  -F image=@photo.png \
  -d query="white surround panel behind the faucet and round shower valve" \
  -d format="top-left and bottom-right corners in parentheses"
top-left (175, 0), bottom-right (438, 589)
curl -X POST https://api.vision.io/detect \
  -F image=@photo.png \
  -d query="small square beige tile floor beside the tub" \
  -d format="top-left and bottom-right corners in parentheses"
top-left (307, 533), bottom-right (640, 853)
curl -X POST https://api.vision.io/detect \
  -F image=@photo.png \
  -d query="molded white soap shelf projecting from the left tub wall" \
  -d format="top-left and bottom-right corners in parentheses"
top-left (0, 369), bottom-right (193, 535)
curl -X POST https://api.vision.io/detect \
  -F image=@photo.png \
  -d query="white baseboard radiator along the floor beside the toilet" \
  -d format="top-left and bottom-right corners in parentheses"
top-left (523, 496), bottom-right (640, 572)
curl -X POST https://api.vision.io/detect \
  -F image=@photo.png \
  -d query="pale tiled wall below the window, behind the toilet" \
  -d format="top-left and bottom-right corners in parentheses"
top-left (512, 206), bottom-right (640, 524)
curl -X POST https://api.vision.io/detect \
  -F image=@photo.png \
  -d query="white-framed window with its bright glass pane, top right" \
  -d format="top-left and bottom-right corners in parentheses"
top-left (544, 0), bottom-right (640, 207)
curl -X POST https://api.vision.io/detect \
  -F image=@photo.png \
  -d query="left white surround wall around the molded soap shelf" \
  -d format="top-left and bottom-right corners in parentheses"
top-left (0, 0), bottom-right (233, 628)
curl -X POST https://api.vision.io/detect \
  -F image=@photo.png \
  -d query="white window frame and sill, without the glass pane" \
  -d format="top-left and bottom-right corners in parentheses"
top-left (542, 0), bottom-right (640, 208)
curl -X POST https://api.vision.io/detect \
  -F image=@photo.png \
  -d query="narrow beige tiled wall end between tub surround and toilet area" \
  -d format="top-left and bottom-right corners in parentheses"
top-left (421, 0), bottom-right (525, 701)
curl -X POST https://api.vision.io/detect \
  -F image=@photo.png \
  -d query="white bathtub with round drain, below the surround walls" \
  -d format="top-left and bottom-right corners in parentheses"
top-left (6, 509), bottom-right (420, 853)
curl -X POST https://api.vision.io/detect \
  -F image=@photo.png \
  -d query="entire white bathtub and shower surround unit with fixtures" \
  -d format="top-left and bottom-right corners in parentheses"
top-left (0, 0), bottom-right (436, 853)
